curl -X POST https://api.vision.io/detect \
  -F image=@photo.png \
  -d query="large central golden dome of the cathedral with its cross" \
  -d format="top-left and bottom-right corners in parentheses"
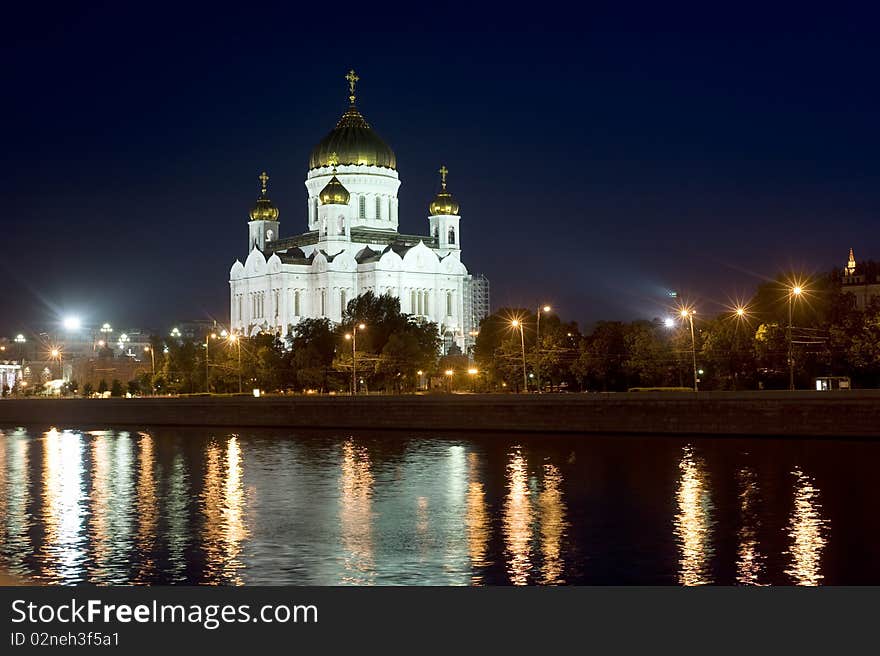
top-left (309, 71), bottom-right (397, 170)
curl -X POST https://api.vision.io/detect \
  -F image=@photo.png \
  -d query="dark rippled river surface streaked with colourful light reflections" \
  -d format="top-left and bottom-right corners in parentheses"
top-left (0, 429), bottom-right (880, 585)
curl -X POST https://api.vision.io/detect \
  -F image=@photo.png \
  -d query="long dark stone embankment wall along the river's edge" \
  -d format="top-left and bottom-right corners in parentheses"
top-left (0, 390), bottom-right (880, 438)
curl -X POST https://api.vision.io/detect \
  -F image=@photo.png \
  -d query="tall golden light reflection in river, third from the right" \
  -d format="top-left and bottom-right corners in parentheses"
top-left (675, 445), bottom-right (715, 585)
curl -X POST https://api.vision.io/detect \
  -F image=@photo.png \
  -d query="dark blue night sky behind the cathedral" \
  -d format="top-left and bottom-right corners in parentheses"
top-left (0, 3), bottom-right (880, 335)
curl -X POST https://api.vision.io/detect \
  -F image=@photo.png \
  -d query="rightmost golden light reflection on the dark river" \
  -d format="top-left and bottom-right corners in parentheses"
top-left (785, 468), bottom-right (830, 585)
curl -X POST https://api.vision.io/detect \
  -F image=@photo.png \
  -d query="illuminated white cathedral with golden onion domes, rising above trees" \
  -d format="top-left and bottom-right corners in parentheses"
top-left (229, 71), bottom-right (488, 353)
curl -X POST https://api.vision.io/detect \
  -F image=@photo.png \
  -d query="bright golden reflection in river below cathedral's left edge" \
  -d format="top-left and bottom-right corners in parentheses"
top-left (202, 435), bottom-right (247, 585)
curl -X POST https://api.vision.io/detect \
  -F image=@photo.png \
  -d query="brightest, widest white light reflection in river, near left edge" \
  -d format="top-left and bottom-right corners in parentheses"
top-left (37, 428), bottom-right (87, 583)
